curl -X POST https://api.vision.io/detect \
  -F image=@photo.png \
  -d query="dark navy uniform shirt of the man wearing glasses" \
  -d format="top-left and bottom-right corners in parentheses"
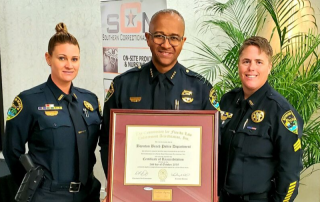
top-left (99, 61), bottom-right (220, 175)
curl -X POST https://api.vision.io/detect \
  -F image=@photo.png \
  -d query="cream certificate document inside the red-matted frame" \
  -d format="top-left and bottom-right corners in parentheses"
top-left (124, 125), bottom-right (202, 186)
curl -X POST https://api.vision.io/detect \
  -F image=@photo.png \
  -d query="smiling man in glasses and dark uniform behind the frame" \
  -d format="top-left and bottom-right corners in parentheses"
top-left (100, 9), bottom-right (219, 194)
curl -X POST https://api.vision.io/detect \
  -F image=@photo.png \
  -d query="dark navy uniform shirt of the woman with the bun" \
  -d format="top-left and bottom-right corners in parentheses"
top-left (3, 76), bottom-right (101, 183)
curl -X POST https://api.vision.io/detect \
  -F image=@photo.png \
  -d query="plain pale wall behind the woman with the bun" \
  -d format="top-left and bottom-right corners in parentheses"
top-left (0, 0), bottom-right (104, 191)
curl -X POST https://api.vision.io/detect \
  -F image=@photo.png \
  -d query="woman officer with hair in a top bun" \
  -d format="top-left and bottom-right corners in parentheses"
top-left (3, 23), bottom-right (101, 202)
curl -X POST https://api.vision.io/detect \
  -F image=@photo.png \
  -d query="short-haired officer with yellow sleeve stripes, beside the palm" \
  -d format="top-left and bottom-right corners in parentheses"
top-left (218, 36), bottom-right (303, 202)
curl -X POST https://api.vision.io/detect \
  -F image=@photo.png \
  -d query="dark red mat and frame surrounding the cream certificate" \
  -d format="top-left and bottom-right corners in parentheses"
top-left (107, 109), bottom-right (219, 202)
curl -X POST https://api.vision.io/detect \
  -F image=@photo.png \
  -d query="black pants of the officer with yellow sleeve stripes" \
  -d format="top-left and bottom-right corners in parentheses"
top-left (219, 191), bottom-right (271, 202)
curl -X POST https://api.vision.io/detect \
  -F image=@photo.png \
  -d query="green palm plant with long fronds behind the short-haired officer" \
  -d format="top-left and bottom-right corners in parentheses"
top-left (190, 0), bottom-right (320, 172)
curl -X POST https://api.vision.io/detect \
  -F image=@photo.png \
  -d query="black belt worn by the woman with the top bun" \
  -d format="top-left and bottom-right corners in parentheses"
top-left (40, 174), bottom-right (94, 193)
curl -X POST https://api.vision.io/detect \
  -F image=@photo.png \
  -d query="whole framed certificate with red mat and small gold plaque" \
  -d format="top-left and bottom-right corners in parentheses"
top-left (107, 109), bottom-right (219, 202)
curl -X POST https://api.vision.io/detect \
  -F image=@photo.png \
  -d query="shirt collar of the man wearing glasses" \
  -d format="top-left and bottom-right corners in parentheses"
top-left (149, 61), bottom-right (182, 85)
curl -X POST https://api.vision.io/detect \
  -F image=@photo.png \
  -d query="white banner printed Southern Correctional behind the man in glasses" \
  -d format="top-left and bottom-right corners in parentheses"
top-left (101, 0), bottom-right (167, 94)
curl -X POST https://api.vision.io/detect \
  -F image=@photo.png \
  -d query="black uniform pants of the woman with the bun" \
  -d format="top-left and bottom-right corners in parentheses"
top-left (32, 176), bottom-right (101, 202)
